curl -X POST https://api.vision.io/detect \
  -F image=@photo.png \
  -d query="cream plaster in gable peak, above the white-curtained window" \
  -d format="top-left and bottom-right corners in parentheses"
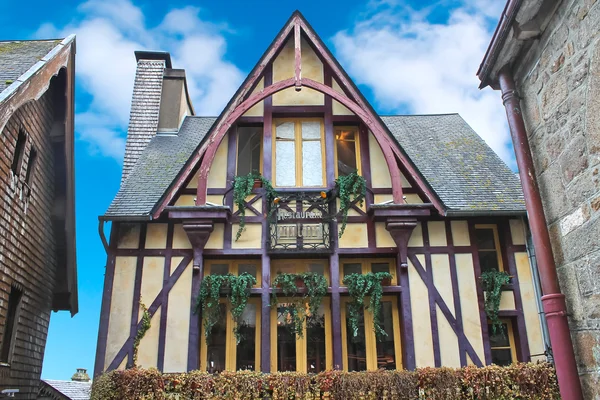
top-left (273, 38), bottom-right (324, 106)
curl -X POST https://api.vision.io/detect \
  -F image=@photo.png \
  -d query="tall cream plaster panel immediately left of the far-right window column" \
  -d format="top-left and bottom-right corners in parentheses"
top-left (458, 254), bottom-right (485, 362)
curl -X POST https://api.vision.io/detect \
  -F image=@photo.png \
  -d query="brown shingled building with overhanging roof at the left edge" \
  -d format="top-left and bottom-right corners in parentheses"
top-left (0, 36), bottom-right (78, 399)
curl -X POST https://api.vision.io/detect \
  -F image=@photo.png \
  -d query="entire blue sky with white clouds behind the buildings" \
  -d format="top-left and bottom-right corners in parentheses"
top-left (0, 0), bottom-right (508, 379)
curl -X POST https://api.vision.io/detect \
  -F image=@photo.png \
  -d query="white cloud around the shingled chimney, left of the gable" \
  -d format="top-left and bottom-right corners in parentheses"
top-left (36, 0), bottom-right (243, 162)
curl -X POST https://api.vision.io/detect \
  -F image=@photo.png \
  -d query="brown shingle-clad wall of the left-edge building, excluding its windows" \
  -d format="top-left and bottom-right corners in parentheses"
top-left (0, 89), bottom-right (56, 399)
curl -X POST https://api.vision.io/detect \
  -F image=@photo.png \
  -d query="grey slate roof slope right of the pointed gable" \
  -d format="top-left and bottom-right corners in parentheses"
top-left (381, 114), bottom-right (525, 215)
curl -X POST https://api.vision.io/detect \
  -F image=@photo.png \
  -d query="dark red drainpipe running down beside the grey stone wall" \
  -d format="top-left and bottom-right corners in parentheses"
top-left (498, 68), bottom-right (583, 400)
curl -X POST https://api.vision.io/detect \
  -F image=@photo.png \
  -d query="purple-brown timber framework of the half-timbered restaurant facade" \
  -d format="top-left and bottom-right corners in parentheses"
top-left (95, 12), bottom-right (531, 375)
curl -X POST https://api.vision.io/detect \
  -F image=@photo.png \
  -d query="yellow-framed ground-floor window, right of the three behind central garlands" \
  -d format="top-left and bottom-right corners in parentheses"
top-left (341, 296), bottom-right (402, 371)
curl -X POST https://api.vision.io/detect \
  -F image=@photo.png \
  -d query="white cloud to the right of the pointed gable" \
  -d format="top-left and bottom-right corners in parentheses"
top-left (333, 0), bottom-right (515, 167)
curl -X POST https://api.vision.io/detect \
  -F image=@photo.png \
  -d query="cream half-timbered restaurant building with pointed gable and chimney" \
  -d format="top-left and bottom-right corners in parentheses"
top-left (95, 12), bottom-right (546, 374)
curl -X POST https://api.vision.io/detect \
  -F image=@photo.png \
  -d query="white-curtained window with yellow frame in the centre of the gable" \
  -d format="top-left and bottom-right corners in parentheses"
top-left (273, 119), bottom-right (325, 187)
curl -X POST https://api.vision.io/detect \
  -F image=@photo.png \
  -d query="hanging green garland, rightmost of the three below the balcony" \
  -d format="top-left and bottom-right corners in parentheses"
top-left (343, 272), bottom-right (392, 340)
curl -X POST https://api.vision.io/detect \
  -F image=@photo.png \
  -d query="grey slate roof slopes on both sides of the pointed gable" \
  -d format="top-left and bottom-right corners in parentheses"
top-left (105, 114), bottom-right (525, 219)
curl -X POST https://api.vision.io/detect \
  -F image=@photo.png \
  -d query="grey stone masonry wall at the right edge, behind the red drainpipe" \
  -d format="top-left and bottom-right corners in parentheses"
top-left (515, 0), bottom-right (600, 399)
